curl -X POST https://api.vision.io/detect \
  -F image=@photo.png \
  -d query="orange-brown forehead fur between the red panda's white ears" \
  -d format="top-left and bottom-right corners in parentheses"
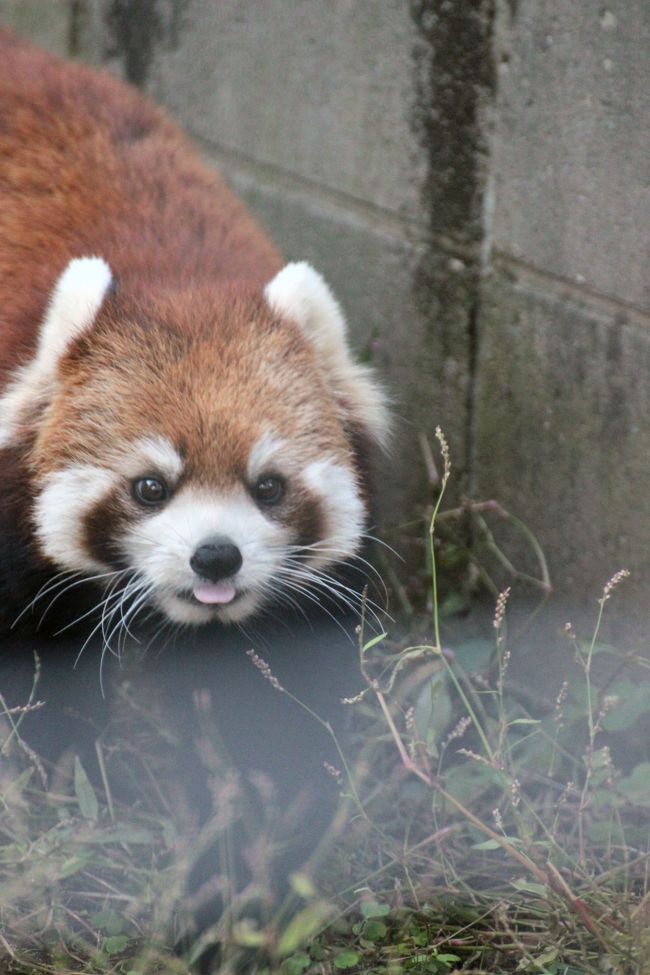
top-left (34, 289), bottom-right (351, 488)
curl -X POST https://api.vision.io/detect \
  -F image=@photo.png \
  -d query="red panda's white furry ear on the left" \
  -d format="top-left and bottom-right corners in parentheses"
top-left (0, 257), bottom-right (113, 448)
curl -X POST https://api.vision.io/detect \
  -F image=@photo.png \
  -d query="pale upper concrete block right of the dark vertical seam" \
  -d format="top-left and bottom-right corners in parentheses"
top-left (492, 0), bottom-right (650, 312)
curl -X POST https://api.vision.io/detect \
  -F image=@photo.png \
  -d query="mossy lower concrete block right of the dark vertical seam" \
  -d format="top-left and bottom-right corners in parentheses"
top-left (476, 275), bottom-right (650, 606)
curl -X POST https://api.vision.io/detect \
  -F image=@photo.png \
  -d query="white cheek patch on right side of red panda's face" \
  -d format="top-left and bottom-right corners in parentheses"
top-left (303, 458), bottom-right (365, 564)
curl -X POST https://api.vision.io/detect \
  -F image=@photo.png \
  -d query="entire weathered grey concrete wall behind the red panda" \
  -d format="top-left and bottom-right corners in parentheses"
top-left (0, 0), bottom-right (650, 608)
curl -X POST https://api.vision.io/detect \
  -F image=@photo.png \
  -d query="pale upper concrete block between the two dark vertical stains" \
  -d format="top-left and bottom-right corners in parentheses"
top-left (103, 0), bottom-right (426, 220)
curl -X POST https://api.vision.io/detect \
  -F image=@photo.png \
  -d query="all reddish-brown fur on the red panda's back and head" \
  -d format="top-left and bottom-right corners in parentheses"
top-left (0, 30), bottom-right (374, 632)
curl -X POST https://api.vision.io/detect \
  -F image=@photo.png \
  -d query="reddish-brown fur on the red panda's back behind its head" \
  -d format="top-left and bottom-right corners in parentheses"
top-left (0, 29), bottom-right (281, 386)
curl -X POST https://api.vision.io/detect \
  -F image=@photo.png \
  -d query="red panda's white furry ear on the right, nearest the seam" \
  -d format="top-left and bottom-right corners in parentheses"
top-left (264, 261), bottom-right (389, 447)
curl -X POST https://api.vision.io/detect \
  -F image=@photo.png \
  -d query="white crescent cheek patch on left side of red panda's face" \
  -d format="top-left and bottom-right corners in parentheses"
top-left (34, 464), bottom-right (119, 572)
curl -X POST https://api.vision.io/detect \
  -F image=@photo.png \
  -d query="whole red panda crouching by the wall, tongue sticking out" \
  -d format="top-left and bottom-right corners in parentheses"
top-left (0, 31), bottom-right (387, 629)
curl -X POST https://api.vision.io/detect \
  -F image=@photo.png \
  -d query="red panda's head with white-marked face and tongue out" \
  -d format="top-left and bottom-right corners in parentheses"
top-left (0, 261), bottom-right (383, 624)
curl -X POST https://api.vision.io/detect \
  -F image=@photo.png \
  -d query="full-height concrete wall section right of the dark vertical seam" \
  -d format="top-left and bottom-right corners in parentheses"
top-left (474, 0), bottom-right (650, 602)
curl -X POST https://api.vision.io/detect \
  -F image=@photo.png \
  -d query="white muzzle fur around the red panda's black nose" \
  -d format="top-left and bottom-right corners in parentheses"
top-left (122, 486), bottom-right (290, 623)
